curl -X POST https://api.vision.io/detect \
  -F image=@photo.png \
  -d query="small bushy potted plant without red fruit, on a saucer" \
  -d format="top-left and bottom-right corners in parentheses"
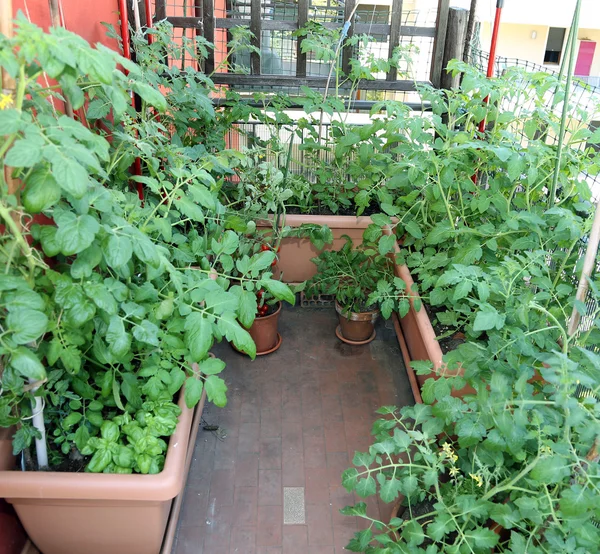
top-left (298, 237), bottom-right (409, 344)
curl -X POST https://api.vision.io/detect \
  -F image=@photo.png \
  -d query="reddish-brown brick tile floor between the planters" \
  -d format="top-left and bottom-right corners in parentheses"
top-left (173, 308), bottom-right (413, 554)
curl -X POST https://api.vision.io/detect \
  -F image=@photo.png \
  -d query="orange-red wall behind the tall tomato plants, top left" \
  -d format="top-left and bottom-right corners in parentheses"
top-left (12, 0), bottom-right (119, 49)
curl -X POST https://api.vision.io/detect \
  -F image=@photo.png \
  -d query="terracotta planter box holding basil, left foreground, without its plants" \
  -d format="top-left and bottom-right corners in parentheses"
top-left (0, 388), bottom-right (205, 554)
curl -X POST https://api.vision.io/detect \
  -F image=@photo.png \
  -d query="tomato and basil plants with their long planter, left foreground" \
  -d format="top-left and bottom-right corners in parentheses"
top-left (0, 20), bottom-right (255, 554)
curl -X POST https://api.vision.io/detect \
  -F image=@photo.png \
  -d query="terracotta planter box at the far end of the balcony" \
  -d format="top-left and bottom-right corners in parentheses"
top-left (257, 214), bottom-right (380, 283)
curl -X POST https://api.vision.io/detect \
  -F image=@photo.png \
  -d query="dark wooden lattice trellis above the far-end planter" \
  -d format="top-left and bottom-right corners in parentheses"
top-left (154, 0), bottom-right (450, 92)
